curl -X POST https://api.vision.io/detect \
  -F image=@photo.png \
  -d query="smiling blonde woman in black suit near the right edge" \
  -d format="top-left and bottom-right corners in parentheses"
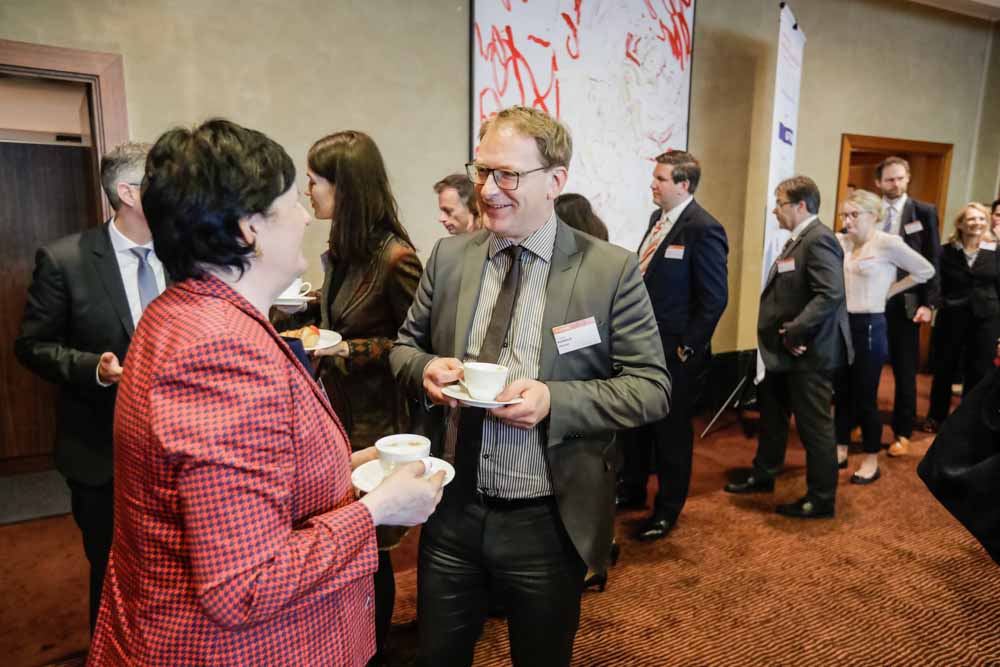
top-left (924, 202), bottom-right (1000, 432)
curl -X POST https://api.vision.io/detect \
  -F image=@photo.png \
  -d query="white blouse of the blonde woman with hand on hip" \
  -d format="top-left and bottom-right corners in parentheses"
top-left (837, 231), bottom-right (934, 313)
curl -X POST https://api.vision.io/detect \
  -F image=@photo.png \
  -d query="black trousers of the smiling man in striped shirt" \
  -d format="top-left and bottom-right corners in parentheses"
top-left (417, 493), bottom-right (587, 667)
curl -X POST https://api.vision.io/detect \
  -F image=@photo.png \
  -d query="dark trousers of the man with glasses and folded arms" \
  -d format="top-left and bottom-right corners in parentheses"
top-left (753, 371), bottom-right (837, 505)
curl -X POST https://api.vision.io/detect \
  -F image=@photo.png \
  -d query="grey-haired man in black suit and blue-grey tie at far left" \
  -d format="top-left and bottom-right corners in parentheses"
top-left (14, 143), bottom-right (164, 632)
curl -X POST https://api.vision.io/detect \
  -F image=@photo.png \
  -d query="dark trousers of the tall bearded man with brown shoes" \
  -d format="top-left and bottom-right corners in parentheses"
top-left (885, 294), bottom-right (920, 438)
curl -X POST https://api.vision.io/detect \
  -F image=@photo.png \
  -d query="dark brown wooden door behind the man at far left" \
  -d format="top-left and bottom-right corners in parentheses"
top-left (0, 142), bottom-right (100, 473)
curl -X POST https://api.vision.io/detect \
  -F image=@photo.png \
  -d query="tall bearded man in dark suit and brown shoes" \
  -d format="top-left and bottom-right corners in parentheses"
top-left (875, 156), bottom-right (941, 456)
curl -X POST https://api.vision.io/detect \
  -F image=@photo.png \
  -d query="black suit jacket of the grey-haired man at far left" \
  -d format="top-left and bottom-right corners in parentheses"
top-left (14, 223), bottom-right (134, 484)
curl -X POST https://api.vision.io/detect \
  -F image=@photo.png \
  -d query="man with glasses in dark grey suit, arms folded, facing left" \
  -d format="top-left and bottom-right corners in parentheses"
top-left (726, 176), bottom-right (853, 518)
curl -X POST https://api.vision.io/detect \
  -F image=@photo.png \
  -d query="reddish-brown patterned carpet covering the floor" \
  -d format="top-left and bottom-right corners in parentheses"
top-left (0, 373), bottom-right (1000, 667)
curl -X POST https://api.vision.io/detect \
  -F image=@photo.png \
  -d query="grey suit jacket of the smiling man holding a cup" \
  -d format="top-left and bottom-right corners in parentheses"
top-left (389, 221), bottom-right (670, 571)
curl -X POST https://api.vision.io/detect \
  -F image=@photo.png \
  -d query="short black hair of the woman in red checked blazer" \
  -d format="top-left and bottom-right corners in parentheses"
top-left (142, 118), bottom-right (295, 281)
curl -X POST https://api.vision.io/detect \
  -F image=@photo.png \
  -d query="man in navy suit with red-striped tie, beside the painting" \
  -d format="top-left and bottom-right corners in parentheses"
top-left (619, 151), bottom-right (729, 540)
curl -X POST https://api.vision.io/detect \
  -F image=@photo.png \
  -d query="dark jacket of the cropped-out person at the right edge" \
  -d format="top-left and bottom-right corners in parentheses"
top-left (917, 370), bottom-right (1000, 564)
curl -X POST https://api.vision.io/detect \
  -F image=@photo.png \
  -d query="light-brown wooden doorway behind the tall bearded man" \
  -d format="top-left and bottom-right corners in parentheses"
top-left (834, 134), bottom-right (953, 371)
